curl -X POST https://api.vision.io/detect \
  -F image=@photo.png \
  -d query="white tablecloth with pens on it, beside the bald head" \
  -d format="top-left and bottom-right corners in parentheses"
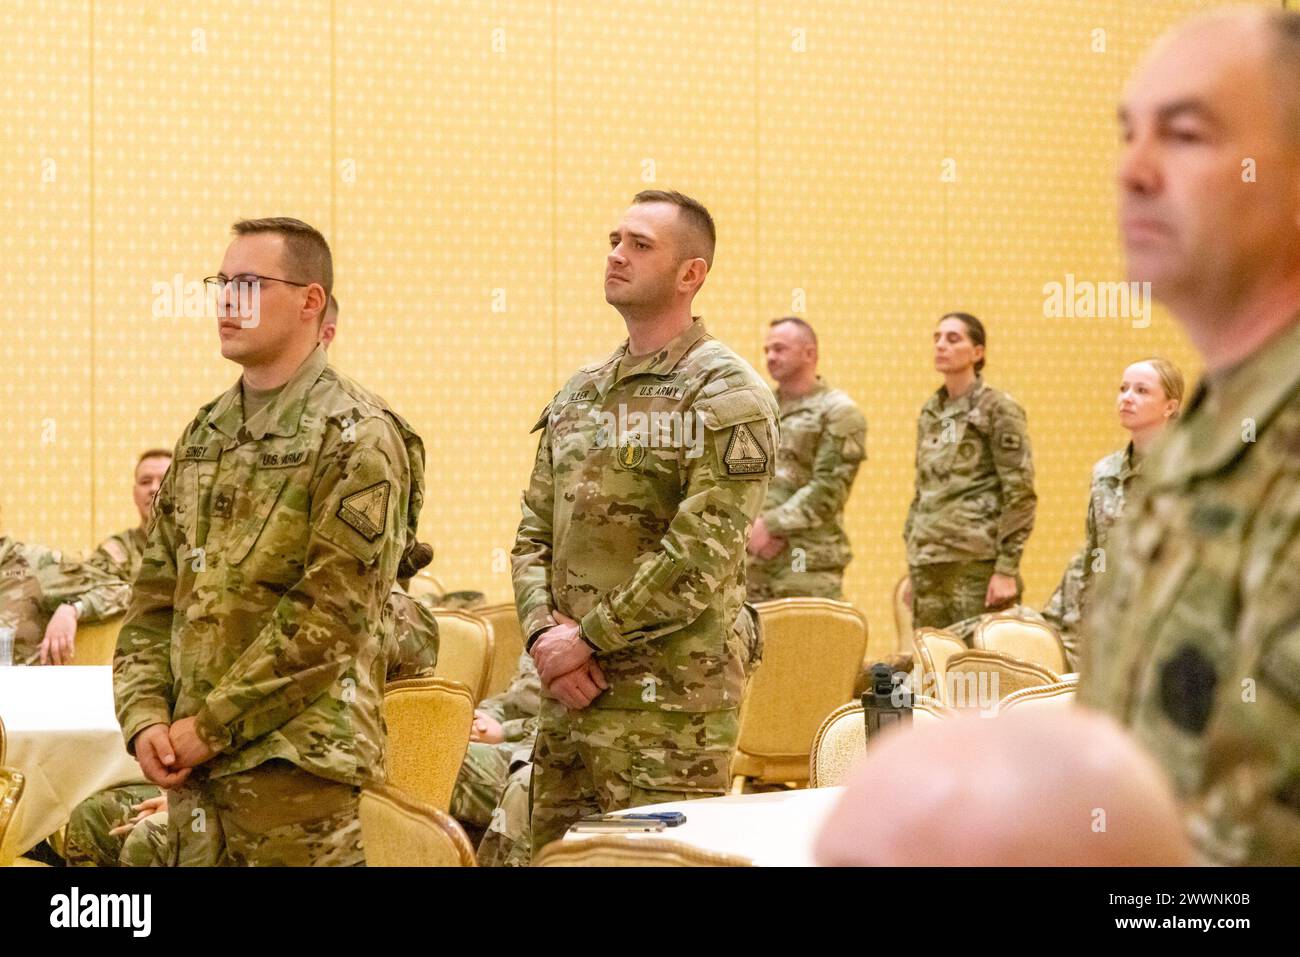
top-left (564, 788), bottom-right (844, 867)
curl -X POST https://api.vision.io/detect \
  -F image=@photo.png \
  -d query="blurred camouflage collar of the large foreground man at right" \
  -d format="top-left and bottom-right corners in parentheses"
top-left (1148, 321), bottom-right (1300, 488)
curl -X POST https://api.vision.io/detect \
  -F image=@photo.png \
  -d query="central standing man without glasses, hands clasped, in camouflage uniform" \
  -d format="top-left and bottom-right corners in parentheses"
top-left (514, 190), bottom-right (776, 854)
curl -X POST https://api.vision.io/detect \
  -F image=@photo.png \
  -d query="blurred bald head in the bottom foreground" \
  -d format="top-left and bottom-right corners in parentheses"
top-left (816, 706), bottom-right (1192, 867)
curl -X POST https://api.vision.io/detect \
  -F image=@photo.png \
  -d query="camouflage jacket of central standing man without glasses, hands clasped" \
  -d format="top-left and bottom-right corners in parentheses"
top-left (512, 320), bottom-right (777, 711)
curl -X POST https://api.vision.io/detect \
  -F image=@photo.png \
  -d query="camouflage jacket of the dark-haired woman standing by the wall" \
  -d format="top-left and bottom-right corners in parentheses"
top-left (904, 377), bottom-right (1037, 575)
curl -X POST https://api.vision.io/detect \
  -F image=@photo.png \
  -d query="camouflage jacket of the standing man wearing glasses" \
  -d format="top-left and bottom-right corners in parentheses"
top-left (113, 348), bottom-right (424, 784)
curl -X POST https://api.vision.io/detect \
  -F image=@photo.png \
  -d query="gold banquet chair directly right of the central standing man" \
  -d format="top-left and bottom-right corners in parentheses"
top-left (731, 598), bottom-right (867, 794)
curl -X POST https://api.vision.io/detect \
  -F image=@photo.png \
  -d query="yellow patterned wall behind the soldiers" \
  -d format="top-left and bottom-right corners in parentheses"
top-left (0, 0), bottom-right (1277, 665)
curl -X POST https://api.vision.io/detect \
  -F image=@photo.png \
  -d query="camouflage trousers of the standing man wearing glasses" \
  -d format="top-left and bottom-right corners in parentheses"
top-left (168, 759), bottom-right (365, 867)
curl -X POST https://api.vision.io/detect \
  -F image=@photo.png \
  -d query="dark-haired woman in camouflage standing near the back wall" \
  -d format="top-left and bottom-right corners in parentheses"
top-left (902, 312), bottom-right (1037, 628)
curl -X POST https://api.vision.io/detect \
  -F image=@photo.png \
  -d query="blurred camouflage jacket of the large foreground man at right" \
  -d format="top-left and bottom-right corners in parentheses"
top-left (1079, 321), bottom-right (1300, 865)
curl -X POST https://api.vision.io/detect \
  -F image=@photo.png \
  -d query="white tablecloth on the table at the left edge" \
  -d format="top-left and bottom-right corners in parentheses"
top-left (0, 666), bottom-right (144, 857)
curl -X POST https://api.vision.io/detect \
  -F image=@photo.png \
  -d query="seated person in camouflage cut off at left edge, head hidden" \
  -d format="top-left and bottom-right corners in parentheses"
top-left (0, 536), bottom-right (131, 664)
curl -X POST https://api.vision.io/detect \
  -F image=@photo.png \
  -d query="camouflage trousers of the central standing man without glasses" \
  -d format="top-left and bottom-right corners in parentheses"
top-left (532, 698), bottom-right (740, 861)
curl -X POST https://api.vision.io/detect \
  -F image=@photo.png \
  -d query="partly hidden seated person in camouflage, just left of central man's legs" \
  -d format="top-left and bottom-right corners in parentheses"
top-left (451, 651), bottom-right (542, 866)
